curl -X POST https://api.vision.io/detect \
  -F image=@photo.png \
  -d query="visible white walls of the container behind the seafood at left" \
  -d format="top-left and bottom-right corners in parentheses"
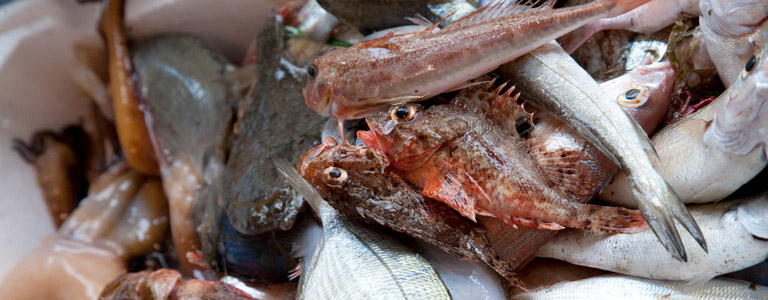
top-left (0, 0), bottom-right (288, 278)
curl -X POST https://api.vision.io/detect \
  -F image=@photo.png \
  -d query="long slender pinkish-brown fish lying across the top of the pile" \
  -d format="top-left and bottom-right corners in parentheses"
top-left (302, 0), bottom-right (648, 141)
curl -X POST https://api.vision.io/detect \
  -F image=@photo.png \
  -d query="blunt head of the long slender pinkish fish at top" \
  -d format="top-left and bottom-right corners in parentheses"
top-left (301, 49), bottom-right (339, 116)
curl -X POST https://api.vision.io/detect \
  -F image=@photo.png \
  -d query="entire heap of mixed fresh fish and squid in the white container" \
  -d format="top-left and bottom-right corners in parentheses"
top-left (0, 0), bottom-right (768, 299)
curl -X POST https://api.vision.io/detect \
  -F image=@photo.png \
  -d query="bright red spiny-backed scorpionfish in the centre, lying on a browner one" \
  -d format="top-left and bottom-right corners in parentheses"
top-left (358, 85), bottom-right (647, 233)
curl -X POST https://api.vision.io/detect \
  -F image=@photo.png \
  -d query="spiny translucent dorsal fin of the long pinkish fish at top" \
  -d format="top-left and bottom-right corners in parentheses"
top-left (443, 0), bottom-right (556, 30)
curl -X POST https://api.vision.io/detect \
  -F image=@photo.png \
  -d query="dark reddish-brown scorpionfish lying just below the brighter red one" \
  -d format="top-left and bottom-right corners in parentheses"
top-left (299, 138), bottom-right (516, 281)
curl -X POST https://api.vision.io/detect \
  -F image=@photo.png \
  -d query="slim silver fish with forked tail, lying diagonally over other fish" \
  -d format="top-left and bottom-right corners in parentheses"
top-left (498, 42), bottom-right (707, 261)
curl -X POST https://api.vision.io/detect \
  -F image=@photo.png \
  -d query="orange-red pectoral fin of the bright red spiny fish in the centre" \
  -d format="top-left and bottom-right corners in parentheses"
top-left (422, 164), bottom-right (490, 221)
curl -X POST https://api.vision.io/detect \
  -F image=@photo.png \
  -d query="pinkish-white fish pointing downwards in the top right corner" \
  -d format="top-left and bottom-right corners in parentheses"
top-left (699, 0), bottom-right (768, 87)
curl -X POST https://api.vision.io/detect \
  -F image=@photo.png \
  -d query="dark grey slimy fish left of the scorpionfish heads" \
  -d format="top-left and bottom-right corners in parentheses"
top-left (222, 14), bottom-right (325, 235)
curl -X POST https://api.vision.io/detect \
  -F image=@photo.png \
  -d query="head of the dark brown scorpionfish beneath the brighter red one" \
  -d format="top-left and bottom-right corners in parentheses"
top-left (298, 138), bottom-right (394, 206)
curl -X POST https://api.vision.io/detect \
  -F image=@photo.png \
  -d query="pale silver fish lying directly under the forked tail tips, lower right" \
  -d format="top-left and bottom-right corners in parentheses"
top-left (537, 194), bottom-right (768, 282)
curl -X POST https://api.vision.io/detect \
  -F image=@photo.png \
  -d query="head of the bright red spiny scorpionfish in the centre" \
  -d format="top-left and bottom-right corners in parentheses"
top-left (357, 104), bottom-right (467, 171)
